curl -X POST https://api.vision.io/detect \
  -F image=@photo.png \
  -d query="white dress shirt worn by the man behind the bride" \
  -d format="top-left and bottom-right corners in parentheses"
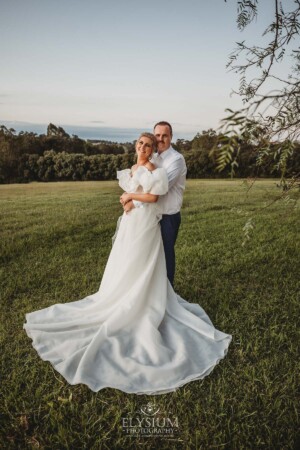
top-left (133, 146), bottom-right (187, 214)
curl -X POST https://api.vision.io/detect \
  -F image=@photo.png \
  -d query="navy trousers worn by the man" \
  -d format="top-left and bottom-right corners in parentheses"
top-left (160, 212), bottom-right (181, 286)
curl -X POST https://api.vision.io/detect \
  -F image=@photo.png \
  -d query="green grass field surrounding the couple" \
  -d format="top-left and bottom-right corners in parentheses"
top-left (0, 180), bottom-right (300, 450)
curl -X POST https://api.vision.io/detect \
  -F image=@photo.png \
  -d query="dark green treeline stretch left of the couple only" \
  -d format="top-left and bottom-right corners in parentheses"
top-left (0, 123), bottom-right (135, 184)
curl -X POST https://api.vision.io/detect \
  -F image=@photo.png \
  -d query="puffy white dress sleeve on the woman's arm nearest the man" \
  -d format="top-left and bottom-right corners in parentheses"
top-left (133, 167), bottom-right (168, 195)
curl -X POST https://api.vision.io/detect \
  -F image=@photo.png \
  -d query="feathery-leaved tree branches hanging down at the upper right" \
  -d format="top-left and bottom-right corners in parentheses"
top-left (218, 0), bottom-right (300, 189)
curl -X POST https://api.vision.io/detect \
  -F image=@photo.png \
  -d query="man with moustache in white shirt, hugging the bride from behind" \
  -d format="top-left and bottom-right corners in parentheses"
top-left (125, 121), bottom-right (187, 286)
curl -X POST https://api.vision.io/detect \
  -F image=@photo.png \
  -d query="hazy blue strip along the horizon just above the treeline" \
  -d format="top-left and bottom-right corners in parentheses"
top-left (0, 120), bottom-right (196, 142)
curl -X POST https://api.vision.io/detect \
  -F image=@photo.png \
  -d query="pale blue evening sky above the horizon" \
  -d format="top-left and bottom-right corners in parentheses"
top-left (0, 0), bottom-right (291, 138)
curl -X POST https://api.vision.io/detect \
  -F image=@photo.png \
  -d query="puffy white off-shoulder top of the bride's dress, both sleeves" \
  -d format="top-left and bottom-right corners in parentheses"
top-left (117, 166), bottom-right (168, 195)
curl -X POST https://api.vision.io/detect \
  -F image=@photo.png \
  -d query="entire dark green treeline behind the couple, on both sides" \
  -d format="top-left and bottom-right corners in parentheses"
top-left (0, 124), bottom-right (300, 184)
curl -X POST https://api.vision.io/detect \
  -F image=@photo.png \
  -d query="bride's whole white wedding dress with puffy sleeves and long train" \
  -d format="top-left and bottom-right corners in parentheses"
top-left (23, 166), bottom-right (231, 395)
